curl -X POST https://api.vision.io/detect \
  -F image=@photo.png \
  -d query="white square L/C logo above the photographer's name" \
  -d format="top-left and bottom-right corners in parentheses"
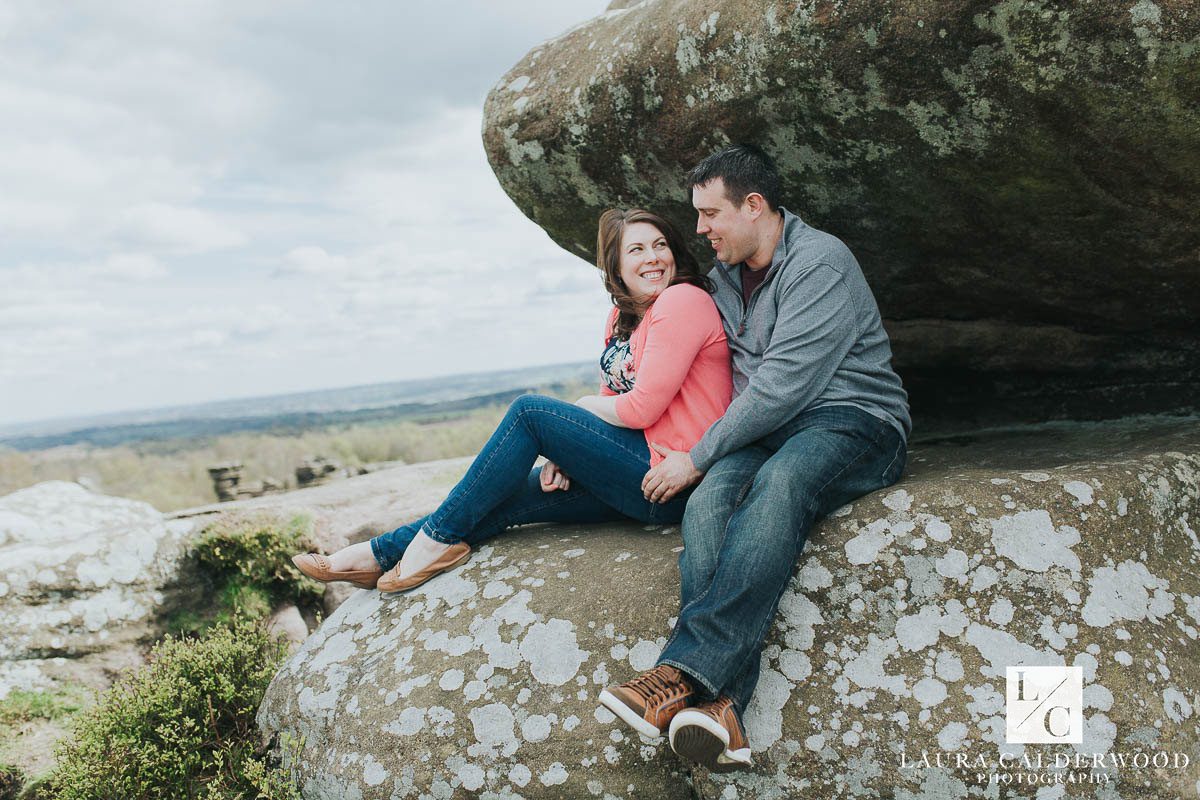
top-left (1004, 667), bottom-right (1084, 745)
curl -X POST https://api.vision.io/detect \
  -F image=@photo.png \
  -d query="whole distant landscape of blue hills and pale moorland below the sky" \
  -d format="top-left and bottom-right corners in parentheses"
top-left (0, 363), bottom-right (596, 511)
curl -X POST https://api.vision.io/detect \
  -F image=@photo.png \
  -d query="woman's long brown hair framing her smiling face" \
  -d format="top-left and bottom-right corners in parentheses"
top-left (596, 209), bottom-right (713, 339)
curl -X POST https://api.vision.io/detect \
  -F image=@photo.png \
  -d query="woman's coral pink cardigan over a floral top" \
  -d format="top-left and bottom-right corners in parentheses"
top-left (600, 283), bottom-right (733, 467)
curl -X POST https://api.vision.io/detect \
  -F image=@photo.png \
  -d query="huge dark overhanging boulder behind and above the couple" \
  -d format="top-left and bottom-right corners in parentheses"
top-left (484, 0), bottom-right (1200, 419)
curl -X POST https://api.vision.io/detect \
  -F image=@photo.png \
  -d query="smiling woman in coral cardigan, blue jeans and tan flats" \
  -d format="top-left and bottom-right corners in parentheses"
top-left (293, 209), bottom-right (732, 591)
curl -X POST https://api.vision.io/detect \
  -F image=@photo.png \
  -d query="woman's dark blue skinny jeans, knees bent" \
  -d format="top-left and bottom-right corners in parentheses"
top-left (371, 395), bottom-right (688, 570)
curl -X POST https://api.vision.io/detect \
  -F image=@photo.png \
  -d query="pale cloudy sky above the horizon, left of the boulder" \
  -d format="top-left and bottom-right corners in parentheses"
top-left (0, 0), bottom-right (608, 425)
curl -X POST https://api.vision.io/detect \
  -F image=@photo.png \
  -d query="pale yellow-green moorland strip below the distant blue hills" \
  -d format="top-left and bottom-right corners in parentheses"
top-left (0, 385), bottom-right (593, 511)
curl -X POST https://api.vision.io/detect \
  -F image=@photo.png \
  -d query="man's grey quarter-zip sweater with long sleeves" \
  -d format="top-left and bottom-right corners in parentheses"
top-left (690, 207), bottom-right (912, 473)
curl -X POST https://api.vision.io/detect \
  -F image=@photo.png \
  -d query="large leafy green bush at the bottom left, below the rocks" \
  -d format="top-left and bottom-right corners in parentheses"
top-left (43, 616), bottom-right (300, 800)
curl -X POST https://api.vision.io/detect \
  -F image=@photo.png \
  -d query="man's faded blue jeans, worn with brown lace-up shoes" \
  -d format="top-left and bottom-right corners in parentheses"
top-left (659, 405), bottom-right (907, 711)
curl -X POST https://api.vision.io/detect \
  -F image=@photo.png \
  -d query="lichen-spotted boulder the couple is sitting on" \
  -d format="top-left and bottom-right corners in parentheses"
top-left (259, 419), bottom-right (1200, 800)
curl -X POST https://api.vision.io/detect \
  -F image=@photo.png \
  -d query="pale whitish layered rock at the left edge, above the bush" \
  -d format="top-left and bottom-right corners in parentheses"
top-left (0, 481), bottom-right (194, 698)
